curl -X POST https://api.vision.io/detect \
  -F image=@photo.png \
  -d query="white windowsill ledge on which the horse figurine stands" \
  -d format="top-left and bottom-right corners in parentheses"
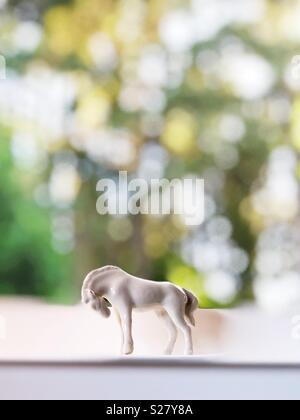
top-left (0, 299), bottom-right (300, 399)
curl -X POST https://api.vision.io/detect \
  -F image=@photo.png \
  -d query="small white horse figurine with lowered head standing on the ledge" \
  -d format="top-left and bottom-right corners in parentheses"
top-left (82, 266), bottom-right (198, 355)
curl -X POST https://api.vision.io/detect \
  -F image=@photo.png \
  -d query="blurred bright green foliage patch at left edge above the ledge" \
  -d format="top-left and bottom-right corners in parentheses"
top-left (0, 127), bottom-right (72, 300)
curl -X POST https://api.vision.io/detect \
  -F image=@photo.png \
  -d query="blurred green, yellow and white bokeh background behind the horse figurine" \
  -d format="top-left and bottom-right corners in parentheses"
top-left (0, 0), bottom-right (300, 309)
